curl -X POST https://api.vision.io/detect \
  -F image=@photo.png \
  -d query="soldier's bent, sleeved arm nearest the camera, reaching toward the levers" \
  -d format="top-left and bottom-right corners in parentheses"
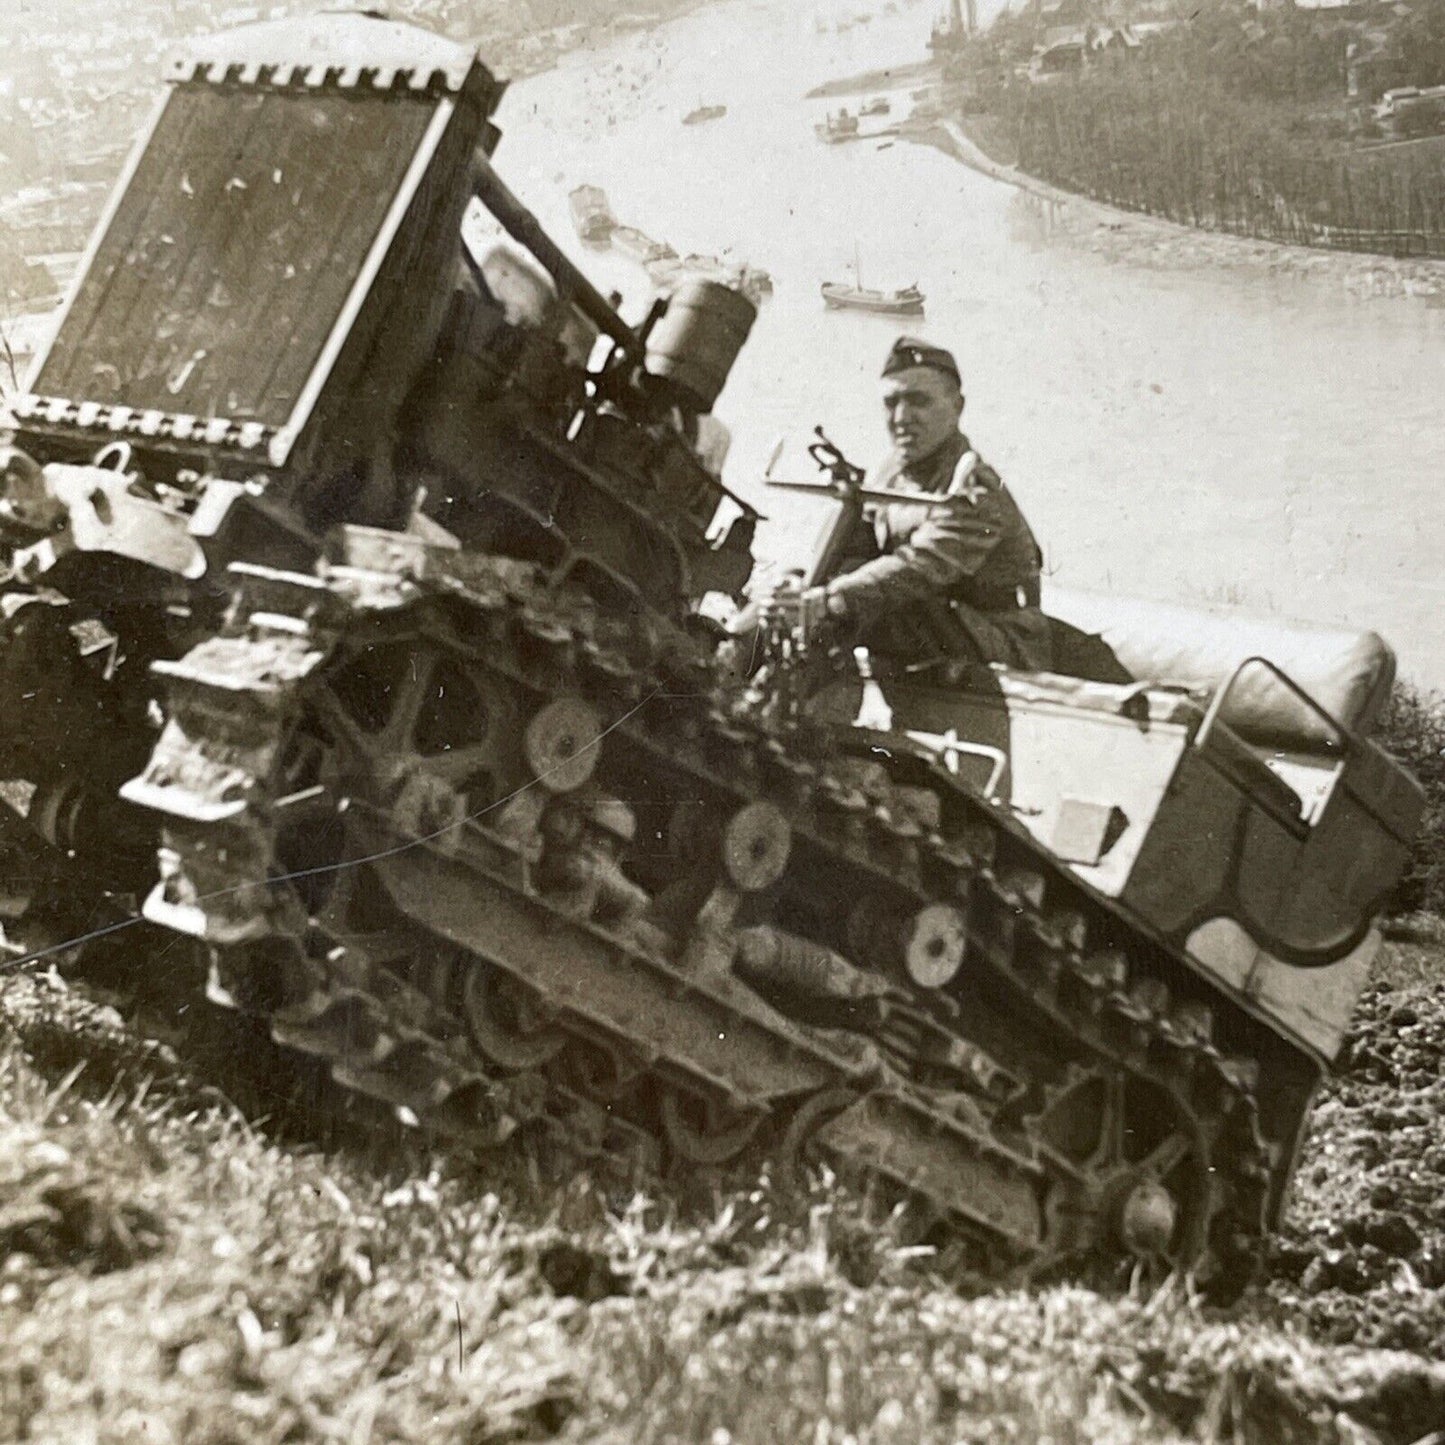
top-left (828, 491), bottom-right (1003, 623)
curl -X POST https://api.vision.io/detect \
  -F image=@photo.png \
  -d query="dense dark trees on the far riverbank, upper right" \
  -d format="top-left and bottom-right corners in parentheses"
top-left (964, 0), bottom-right (1445, 254)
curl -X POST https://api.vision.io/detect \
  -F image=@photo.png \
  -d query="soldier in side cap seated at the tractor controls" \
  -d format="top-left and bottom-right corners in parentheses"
top-left (764, 337), bottom-right (1051, 670)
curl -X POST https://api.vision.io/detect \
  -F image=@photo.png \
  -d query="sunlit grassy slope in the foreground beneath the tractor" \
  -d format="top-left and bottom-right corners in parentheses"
top-left (0, 955), bottom-right (1445, 1445)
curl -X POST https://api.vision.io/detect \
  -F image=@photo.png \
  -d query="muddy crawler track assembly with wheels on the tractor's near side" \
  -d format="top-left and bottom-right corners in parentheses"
top-left (126, 553), bottom-right (1279, 1289)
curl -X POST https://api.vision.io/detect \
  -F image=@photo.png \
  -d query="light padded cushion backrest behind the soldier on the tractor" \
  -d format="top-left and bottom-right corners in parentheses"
top-left (1043, 584), bottom-right (1394, 753)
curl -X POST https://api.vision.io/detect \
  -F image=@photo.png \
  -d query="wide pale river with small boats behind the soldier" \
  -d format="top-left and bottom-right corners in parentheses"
top-left (497, 0), bottom-right (1445, 688)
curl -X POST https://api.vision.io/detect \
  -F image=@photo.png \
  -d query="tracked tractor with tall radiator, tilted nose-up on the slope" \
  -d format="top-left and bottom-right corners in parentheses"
top-left (4, 14), bottom-right (1419, 1287)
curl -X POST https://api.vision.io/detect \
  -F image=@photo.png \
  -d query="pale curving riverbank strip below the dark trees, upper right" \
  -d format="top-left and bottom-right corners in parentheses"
top-left (924, 117), bottom-right (1445, 305)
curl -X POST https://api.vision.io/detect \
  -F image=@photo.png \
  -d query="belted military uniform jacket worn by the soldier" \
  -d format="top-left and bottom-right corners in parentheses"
top-left (828, 432), bottom-right (1051, 669)
